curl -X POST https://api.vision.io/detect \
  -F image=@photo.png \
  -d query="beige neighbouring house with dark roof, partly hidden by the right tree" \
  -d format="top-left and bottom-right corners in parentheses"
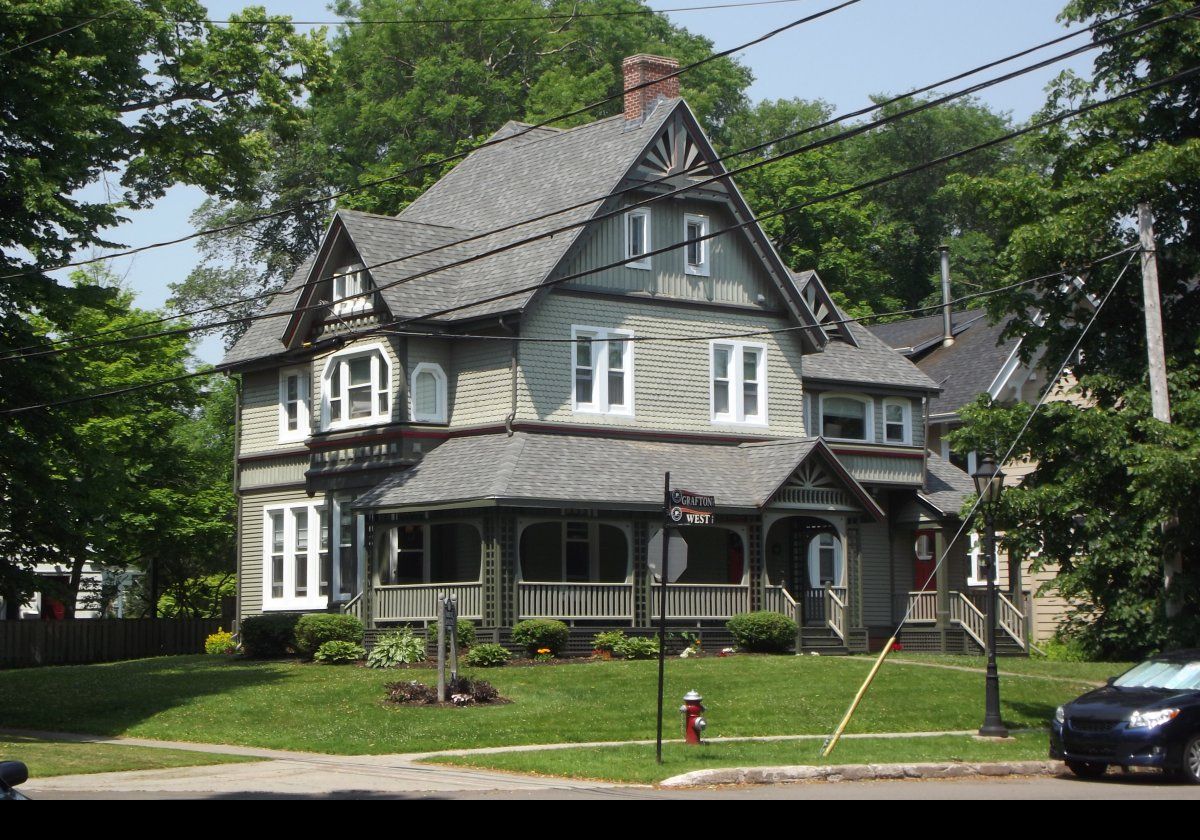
top-left (871, 310), bottom-right (1079, 643)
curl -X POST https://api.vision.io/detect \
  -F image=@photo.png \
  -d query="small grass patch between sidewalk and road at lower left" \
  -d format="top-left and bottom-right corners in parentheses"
top-left (0, 736), bottom-right (257, 779)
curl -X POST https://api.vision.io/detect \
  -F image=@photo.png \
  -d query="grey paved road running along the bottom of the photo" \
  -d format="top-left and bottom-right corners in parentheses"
top-left (23, 762), bottom-right (1200, 802)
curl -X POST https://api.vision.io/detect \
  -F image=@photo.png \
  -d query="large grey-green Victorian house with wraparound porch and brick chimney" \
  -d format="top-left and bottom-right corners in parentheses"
top-left (222, 55), bottom-right (1025, 650)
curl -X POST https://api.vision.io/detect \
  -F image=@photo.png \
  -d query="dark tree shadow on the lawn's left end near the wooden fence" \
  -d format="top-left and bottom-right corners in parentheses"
top-left (0, 656), bottom-right (287, 736)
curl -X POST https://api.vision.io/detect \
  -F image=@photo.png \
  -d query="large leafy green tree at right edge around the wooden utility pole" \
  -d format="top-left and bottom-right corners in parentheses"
top-left (949, 0), bottom-right (1200, 656)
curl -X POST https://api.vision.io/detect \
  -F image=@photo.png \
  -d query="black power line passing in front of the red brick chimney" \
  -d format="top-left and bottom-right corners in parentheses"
top-left (0, 0), bottom-right (862, 280)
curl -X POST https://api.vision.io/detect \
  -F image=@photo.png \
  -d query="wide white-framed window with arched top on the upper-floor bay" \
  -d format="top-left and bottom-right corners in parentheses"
top-left (320, 344), bottom-right (391, 430)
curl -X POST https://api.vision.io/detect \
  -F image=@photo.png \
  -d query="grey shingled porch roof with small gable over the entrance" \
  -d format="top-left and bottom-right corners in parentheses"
top-left (355, 432), bottom-right (883, 518)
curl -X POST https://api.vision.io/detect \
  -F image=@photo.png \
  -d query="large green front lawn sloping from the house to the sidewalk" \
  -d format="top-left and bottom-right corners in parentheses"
top-left (0, 656), bottom-right (1087, 755)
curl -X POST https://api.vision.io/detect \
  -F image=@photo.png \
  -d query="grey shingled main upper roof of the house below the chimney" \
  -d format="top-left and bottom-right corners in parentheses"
top-left (222, 98), bottom-right (824, 365)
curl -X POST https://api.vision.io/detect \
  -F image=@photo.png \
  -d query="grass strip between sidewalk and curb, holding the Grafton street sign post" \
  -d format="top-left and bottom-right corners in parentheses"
top-left (428, 732), bottom-right (1046, 785)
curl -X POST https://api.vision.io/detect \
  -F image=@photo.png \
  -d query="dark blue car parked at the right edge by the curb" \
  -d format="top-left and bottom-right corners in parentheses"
top-left (1050, 650), bottom-right (1200, 784)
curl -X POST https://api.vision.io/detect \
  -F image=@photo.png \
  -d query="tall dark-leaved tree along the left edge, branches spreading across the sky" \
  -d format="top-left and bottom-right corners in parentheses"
top-left (0, 0), bottom-right (326, 604)
